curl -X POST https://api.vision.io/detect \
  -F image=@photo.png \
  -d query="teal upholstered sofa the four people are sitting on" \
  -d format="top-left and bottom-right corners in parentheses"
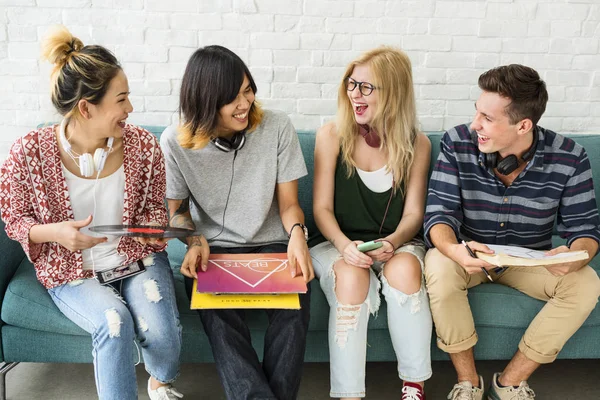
top-left (0, 127), bottom-right (600, 400)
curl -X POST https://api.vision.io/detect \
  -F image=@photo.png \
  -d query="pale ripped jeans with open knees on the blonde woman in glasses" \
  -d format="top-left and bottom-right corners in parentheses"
top-left (310, 240), bottom-right (432, 398)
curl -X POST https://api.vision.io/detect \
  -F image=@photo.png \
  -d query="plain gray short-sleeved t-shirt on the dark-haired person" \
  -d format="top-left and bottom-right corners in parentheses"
top-left (160, 110), bottom-right (307, 247)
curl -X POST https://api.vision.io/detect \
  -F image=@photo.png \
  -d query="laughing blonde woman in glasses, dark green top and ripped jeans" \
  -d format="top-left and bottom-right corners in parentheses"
top-left (311, 47), bottom-right (432, 400)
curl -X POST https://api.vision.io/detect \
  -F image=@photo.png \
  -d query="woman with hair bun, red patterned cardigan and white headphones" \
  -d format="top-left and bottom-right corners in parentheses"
top-left (0, 26), bottom-right (183, 400)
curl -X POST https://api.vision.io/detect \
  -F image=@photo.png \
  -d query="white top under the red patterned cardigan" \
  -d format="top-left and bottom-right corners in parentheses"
top-left (62, 165), bottom-right (126, 271)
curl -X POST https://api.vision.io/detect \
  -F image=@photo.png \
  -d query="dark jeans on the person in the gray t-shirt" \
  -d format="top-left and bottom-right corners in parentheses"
top-left (186, 244), bottom-right (310, 400)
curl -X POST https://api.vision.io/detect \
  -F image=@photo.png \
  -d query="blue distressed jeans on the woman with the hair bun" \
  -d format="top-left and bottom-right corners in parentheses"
top-left (48, 251), bottom-right (181, 400)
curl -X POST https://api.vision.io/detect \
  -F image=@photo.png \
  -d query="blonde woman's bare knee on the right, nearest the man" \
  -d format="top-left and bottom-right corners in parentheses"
top-left (383, 253), bottom-right (421, 294)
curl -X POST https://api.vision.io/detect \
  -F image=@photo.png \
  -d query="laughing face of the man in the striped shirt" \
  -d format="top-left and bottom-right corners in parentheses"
top-left (471, 91), bottom-right (522, 157)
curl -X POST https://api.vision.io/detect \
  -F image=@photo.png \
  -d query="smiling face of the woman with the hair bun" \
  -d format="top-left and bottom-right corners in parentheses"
top-left (87, 70), bottom-right (133, 138)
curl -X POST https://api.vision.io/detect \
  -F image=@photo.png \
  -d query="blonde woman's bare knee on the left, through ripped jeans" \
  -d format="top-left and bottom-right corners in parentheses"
top-left (333, 260), bottom-right (369, 305)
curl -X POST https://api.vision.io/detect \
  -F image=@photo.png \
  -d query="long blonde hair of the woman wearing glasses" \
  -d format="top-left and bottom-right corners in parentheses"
top-left (336, 46), bottom-right (418, 190)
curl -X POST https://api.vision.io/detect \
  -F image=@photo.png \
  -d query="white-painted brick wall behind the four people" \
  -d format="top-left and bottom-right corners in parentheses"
top-left (0, 0), bottom-right (600, 160)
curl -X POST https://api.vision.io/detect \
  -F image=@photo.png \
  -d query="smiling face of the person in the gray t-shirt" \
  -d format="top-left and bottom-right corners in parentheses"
top-left (217, 75), bottom-right (254, 136)
